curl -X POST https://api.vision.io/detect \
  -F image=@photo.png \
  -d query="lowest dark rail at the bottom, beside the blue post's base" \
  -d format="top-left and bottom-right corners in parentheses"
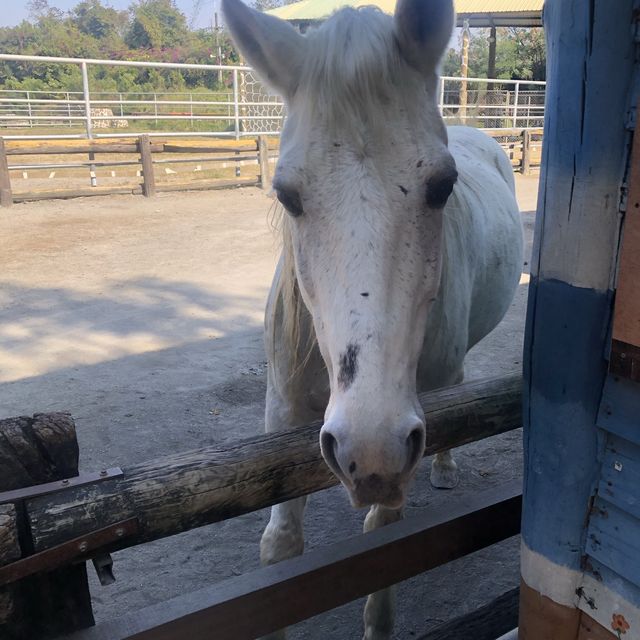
top-left (417, 587), bottom-right (520, 640)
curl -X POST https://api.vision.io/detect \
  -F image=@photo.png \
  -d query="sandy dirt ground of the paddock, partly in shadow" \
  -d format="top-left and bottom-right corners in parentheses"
top-left (0, 176), bottom-right (537, 640)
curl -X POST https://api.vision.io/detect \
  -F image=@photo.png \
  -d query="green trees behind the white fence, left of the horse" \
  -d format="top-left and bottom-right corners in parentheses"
top-left (0, 0), bottom-right (239, 93)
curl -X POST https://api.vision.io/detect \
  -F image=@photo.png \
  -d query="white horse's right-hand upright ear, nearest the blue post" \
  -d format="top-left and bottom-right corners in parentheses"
top-left (394, 0), bottom-right (455, 73)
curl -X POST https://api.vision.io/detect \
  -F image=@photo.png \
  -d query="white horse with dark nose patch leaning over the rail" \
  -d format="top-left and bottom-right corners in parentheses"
top-left (224, 0), bottom-right (523, 639)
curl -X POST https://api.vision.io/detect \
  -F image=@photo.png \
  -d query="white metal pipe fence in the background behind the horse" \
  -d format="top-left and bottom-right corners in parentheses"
top-left (0, 54), bottom-right (545, 139)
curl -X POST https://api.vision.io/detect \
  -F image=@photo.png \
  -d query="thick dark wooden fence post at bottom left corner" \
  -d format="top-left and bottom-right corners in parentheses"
top-left (0, 413), bottom-right (94, 640)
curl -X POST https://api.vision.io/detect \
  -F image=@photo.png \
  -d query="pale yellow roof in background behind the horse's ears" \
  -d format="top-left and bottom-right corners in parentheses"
top-left (267, 0), bottom-right (544, 27)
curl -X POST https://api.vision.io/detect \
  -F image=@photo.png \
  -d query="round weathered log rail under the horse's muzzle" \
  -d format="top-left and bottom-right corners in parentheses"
top-left (27, 375), bottom-right (521, 550)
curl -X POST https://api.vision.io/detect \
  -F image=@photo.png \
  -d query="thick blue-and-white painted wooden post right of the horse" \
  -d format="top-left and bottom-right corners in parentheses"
top-left (519, 0), bottom-right (640, 640)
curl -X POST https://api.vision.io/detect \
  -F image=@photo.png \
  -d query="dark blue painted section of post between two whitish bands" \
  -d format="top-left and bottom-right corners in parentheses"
top-left (522, 278), bottom-right (611, 570)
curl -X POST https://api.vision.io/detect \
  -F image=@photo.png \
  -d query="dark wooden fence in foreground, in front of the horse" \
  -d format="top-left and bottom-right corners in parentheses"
top-left (0, 374), bottom-right (522, 640)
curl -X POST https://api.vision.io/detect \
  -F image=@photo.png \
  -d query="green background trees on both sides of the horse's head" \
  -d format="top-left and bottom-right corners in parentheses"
top-left (0, 0), bottom-right (545, 98)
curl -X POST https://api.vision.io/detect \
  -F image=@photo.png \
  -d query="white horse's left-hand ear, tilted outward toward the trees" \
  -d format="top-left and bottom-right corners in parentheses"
top-left (222, 0), bottom-right (306, 97)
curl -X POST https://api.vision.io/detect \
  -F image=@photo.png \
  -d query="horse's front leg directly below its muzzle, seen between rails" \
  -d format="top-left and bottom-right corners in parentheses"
top-left (363, 505), bottom-right (403, 640)
